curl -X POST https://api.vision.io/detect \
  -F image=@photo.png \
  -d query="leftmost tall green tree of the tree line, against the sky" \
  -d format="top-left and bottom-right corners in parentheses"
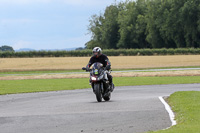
top-left (86, 4), bottom-right (121, 49)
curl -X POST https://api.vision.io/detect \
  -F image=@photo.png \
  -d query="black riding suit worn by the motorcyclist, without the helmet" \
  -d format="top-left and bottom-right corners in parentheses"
top-left (86, 54), bottom-right (112, 84)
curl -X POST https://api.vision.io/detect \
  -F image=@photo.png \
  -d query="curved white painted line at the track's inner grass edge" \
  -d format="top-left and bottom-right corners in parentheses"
top-left (159, 97), bottom-right (176, 129)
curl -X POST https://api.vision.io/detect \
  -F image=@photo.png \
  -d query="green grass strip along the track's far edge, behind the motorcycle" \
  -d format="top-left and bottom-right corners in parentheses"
top-left (0, 76), bottom-right (200, 95)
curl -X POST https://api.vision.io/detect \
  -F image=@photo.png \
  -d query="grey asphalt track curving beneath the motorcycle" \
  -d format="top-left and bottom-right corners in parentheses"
top-left (0, 84), bottom-right (200, 133)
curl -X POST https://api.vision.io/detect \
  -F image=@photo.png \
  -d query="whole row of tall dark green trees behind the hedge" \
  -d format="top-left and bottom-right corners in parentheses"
top-left (85, 0), bottom-right (200, 49)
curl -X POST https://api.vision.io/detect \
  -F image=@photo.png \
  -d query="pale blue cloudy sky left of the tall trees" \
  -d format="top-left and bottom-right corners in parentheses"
top-left (0, 0), bottom-right (125, 50)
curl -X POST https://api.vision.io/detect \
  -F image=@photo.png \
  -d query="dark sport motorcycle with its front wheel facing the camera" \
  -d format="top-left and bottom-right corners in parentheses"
top-left (82, 62), bottom-right (114, 102)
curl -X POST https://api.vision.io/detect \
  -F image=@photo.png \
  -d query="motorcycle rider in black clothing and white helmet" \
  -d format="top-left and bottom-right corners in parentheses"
top-left (86, 47), bottom-right (114, 91)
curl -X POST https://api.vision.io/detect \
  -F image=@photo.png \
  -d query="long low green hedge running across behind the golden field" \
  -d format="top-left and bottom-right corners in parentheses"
top-left (0, 48), bottom-right (200, 58)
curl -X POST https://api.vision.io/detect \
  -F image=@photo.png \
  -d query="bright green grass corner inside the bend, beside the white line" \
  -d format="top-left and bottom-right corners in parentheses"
top-left (150, 91), bottom-right (200, 133)
